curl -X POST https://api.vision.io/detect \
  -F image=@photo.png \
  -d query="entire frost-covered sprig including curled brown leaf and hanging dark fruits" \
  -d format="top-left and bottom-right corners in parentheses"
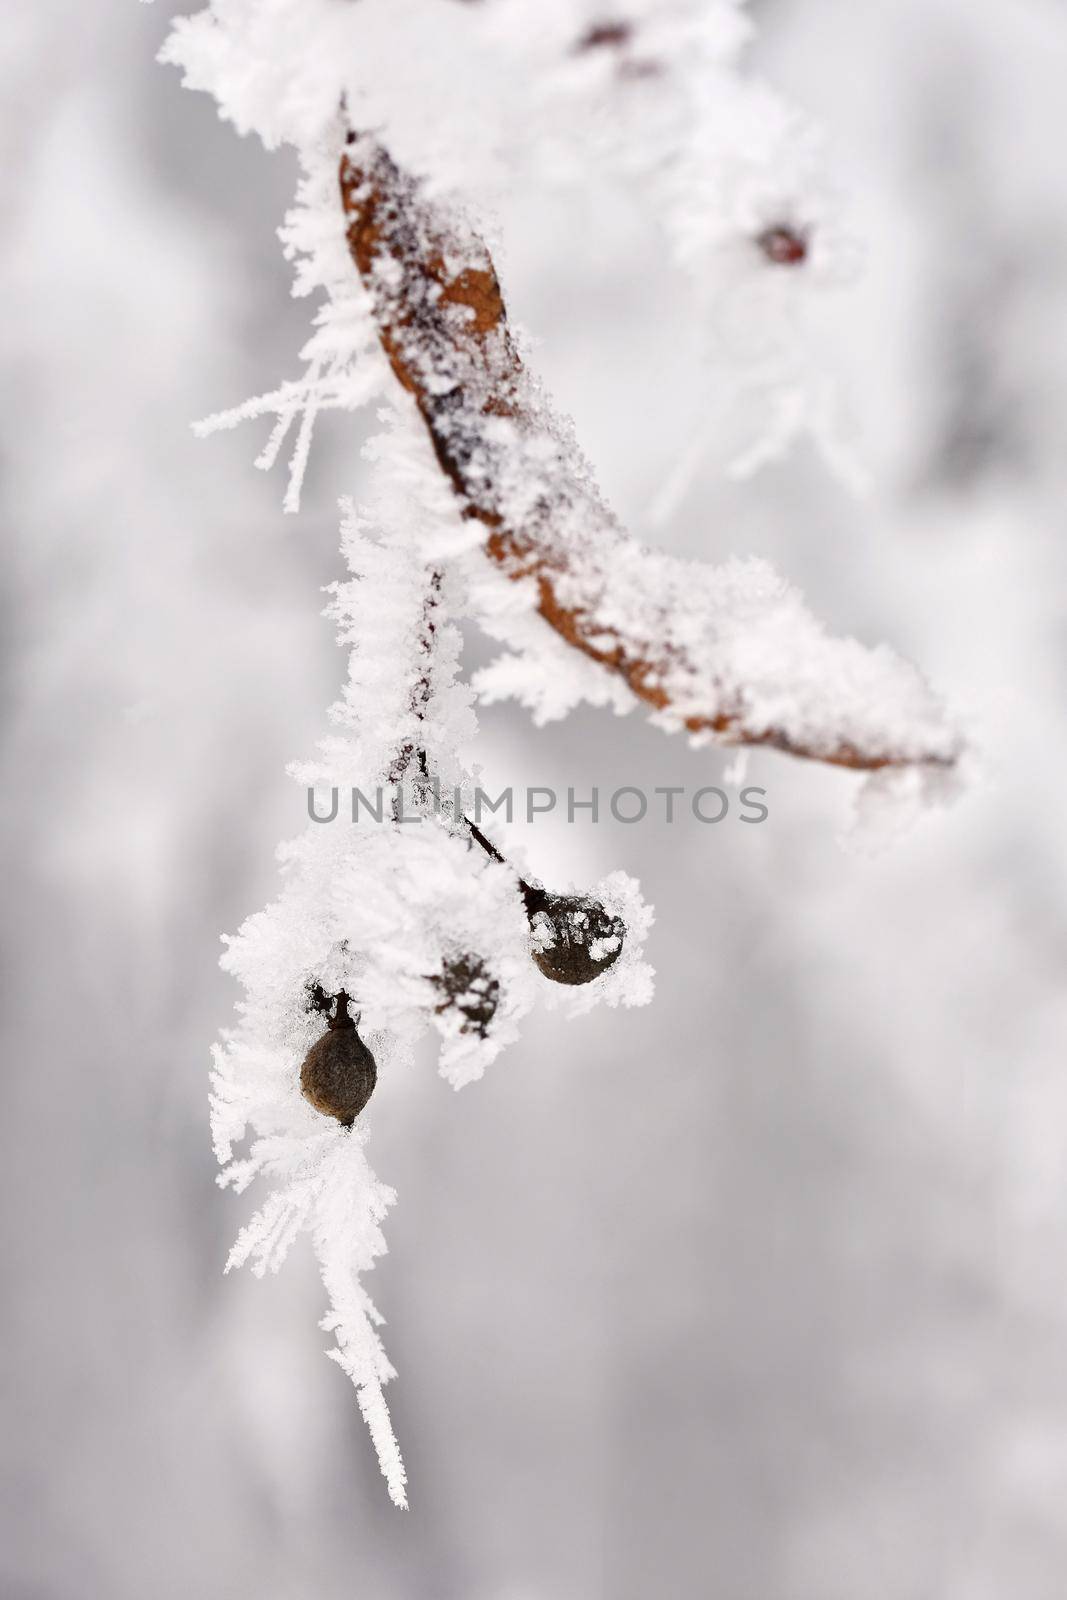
top-left (163, 0), bottom-right (960, 1506)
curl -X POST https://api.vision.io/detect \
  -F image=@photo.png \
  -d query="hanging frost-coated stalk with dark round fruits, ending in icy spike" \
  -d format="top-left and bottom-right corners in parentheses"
top-left (211, 416), bottom-right (651, 1506)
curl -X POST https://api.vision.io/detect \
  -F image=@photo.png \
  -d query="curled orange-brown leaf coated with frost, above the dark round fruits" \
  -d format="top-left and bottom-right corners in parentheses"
top-left (339, 133), bottom-right (961, 771)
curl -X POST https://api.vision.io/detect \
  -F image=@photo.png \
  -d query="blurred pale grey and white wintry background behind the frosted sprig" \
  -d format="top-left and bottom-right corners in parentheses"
top-left (0, 0), bottom-right (1067, 1600)
